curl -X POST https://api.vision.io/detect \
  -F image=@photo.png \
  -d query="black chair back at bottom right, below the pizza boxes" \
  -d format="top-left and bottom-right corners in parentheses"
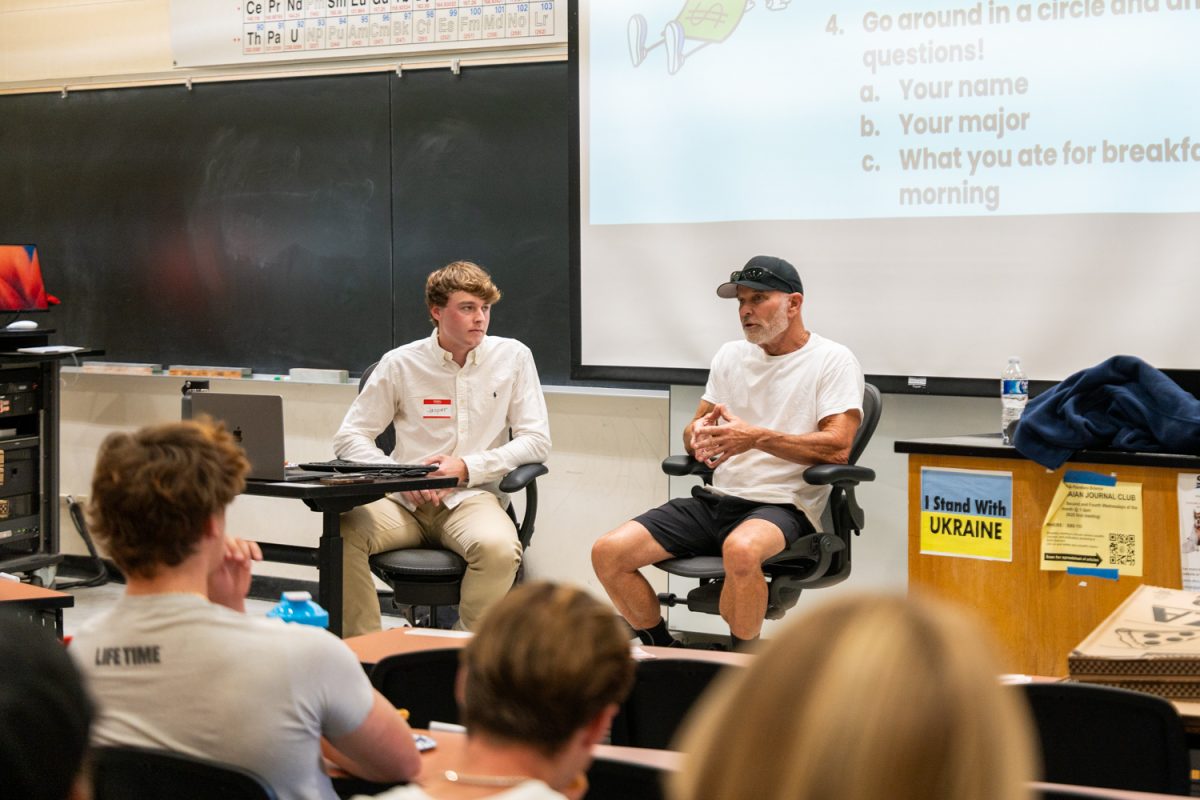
top-left (1021, 682), bottom-right (1190, 794)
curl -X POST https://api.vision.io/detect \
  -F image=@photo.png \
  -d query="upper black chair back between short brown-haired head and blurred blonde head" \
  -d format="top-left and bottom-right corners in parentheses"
top-left (610, 658), bottom-right (736, 750)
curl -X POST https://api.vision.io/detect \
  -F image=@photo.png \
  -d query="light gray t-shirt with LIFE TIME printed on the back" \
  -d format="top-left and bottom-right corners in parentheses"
top-left (68, 594), bottom-right (374, 800)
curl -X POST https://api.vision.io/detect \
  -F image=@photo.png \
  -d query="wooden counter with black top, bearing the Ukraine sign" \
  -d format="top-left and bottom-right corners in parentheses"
top-left (895, 435), bottom-right (1200, 675)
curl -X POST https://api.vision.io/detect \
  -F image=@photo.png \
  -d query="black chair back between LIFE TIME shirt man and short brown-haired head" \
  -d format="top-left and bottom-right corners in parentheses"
top-left (371, 648), bottom-right (462, 728)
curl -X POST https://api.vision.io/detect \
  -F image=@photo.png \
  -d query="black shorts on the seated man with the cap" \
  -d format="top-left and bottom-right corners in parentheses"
top-left (634, 486), bottom-right (815, 558)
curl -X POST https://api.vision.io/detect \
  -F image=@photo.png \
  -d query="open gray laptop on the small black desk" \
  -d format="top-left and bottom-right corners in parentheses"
top-left (182, 391), bottom-right (332, 481)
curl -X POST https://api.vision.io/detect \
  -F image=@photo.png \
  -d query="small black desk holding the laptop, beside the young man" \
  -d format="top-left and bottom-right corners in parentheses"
top-left (245, 477), bottom-right (457, 636)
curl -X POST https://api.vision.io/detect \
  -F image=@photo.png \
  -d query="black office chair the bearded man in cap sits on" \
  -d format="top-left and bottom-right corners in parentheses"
top-left (655, 384), bottom-right (883, 619)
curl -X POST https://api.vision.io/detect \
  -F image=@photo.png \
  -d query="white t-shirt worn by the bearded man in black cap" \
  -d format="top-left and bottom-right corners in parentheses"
top-left (703, 333), bottom-right (864, 530)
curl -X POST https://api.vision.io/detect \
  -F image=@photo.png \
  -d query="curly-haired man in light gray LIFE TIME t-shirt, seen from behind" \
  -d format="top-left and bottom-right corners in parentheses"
top-left (70, 422), bottom-right (420, 799)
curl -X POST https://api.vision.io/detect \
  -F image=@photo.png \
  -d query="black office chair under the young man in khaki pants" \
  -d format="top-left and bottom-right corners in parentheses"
top-left (359, 361), bottom-right (550, 626)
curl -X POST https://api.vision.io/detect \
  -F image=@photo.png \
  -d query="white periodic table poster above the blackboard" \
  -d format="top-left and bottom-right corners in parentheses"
top-left (170, 0), bottom-right (568, 67)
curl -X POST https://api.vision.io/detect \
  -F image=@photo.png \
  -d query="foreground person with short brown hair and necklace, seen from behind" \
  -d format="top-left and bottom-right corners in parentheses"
top-left (362, 583), bottom-right (634, 800)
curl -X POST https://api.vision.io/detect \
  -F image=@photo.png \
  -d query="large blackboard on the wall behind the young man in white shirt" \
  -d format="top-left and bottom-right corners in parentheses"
top-left (0, 64), bottom-right (570, 383)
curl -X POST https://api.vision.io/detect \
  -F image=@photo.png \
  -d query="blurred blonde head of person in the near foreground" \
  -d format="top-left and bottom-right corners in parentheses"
top-left (671, 595), bottom-right (1036, 800)
